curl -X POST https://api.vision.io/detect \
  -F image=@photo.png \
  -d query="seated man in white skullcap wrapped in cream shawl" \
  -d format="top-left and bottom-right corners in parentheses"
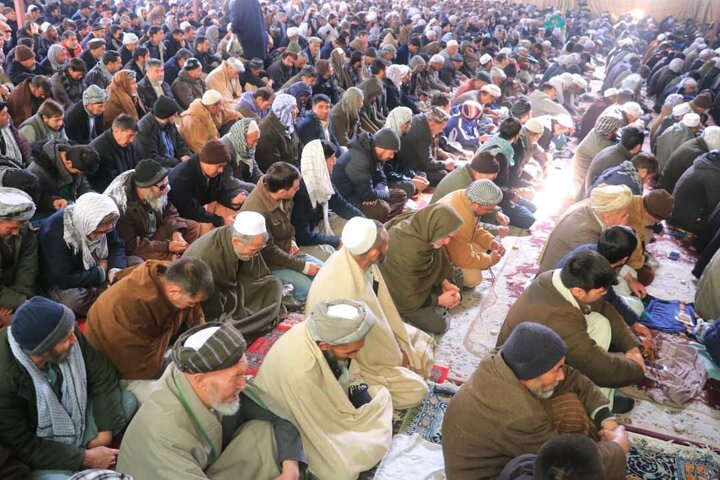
top-left (305, 217), bottom-right (434, 409)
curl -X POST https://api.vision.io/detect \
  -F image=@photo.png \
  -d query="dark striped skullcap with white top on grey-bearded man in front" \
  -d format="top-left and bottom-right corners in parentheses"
top-left (172, 322), bottom-right (247, 373)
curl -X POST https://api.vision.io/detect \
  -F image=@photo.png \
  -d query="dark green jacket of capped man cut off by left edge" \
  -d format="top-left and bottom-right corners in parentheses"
top-left (0, 227), bottom-right (39, 310)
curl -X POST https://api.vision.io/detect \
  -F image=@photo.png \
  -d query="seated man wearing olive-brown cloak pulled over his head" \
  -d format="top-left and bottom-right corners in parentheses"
top-left (380, 203), bottom-right (463, 334)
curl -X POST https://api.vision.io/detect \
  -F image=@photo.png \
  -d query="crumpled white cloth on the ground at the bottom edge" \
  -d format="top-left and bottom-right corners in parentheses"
top-left (373, 433), bottom-right (447, 480)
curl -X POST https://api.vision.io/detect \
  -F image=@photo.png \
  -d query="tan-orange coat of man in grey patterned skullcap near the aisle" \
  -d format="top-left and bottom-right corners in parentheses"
top-left (439, 190), bottom-right (495, 269)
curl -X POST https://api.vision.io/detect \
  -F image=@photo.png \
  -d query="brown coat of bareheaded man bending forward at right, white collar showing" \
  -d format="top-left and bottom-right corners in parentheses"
top-left (497, 270), bottom-right (643, 387)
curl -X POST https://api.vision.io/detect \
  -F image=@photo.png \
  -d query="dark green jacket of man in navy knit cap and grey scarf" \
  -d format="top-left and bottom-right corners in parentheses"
top-left (0, 327), bottom-right (127, 471)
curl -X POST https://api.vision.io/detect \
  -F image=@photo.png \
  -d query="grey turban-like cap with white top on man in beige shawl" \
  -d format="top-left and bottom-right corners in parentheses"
top-left (305, 300), bottom-right (377, 345)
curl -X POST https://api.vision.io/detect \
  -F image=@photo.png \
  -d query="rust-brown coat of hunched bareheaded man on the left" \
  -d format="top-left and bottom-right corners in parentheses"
top-left (85, 260), bottom-right (205, 380)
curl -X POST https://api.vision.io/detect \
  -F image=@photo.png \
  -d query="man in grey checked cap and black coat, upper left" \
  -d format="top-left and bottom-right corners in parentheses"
top-left (65, 85), bottom-right (108, 145)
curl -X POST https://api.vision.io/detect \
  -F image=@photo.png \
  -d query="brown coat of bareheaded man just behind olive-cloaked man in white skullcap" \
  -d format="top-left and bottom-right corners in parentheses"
top-left (240, 175), bottom-right (305, 272)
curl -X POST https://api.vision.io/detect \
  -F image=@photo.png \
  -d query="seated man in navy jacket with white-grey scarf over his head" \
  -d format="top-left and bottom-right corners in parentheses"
top-left (38, 192), bottom-right (127, 316)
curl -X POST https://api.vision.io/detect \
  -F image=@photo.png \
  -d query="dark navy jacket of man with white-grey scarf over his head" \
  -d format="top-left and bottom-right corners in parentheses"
top-left (38, 209), bottom-right (127, 290)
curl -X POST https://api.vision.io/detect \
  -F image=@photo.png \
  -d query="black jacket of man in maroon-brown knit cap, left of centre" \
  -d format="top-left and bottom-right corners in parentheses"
top-left (168, 153), bottom-right (234, 227)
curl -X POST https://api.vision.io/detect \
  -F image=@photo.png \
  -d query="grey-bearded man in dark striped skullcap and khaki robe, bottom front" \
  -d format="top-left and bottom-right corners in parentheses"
top-left (117, 323), bottom-right (307, 480)
